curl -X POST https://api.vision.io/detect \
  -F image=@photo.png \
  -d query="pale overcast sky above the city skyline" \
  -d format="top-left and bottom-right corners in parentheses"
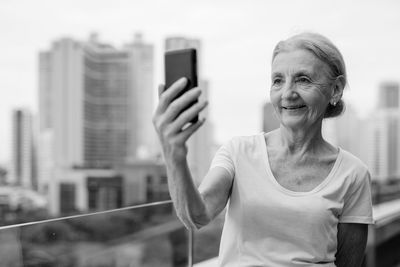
top-left (0, 0), bottom-right (400, 163)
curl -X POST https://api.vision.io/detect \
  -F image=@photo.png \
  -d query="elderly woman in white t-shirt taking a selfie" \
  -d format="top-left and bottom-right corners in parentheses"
top-left (153, 33), bottom-right (373, 267)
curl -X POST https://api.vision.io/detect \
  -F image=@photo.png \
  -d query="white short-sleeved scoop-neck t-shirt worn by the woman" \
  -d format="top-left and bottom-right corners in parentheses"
top-left (210, 133), bottom-right (373, 267)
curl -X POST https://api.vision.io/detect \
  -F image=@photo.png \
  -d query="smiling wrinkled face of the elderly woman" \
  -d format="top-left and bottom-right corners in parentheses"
top-left (270, 49), bottom-right (333, 130)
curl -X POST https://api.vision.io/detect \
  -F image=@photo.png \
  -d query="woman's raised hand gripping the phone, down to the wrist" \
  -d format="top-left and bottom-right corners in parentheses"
top-left (153, 78), bottom-right (208, 161)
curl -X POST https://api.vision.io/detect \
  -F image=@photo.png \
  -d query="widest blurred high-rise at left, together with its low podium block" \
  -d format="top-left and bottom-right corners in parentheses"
top-left (39, 34), bottom-right (159, 215)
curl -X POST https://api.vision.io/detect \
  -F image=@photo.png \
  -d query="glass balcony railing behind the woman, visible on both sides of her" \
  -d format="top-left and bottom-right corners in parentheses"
top-left (0, 200), bottom-right (400, 267)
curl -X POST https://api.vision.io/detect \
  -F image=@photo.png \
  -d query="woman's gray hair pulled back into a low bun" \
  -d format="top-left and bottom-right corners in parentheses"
top-left (272, 32), bottom-right (347, 118)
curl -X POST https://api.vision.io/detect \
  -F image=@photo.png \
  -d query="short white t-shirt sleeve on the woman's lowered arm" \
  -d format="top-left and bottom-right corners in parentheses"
top-left (339, 171), bottom-right (374, 224)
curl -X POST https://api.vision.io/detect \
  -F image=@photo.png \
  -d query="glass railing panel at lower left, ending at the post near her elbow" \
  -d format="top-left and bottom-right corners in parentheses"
top-left (0, 200), bottom-right (194, 267)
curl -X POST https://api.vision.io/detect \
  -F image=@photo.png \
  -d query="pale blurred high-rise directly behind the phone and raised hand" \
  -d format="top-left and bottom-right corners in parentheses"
top-left (165, 36), bottom-right (213, 184)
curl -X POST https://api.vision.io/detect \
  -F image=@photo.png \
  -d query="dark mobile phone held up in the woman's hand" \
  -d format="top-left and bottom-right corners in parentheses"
top-left (164, 48), bottom-right (199, 123)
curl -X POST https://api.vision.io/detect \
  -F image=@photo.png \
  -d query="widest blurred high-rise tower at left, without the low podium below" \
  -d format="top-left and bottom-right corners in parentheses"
top-left (39, 32), bottom-right (156, 168)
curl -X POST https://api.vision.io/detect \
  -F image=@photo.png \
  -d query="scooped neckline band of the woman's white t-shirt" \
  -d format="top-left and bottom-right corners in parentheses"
top-left (260, 132), bottom-right (342, 196)
